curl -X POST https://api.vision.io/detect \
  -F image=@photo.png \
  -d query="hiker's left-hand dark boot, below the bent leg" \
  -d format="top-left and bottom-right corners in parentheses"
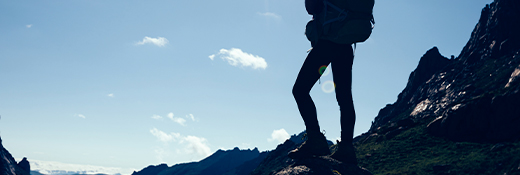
top-left (287, 132), bottom-right (330, 159)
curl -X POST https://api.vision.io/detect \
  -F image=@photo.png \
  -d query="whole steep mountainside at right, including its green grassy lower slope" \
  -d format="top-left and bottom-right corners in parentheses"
top-left (354, 0), bottom-right (520, 174)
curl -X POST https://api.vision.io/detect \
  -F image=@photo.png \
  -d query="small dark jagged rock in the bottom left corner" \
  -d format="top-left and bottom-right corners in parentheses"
top-left (0, 138), bottom-right (30, 175)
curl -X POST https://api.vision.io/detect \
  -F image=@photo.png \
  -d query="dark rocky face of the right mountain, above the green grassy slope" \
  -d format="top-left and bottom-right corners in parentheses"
top-left (355, 0), bottom-right (520, 142)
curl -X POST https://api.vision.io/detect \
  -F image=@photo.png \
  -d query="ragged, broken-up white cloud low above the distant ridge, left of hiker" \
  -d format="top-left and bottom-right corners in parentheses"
top-left (150, 128), bottom-right (211, 157)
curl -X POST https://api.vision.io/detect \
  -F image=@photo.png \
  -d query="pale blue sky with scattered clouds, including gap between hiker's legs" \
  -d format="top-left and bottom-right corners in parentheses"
top-left (0, 0), bottom-right (491, 174)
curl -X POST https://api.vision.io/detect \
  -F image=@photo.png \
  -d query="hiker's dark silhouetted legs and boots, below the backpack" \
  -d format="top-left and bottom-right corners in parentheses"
top-left (289, 40), bottom-right (356, 162)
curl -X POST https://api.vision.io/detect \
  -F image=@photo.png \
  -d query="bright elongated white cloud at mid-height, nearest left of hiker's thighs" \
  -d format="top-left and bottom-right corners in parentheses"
top-left (209, 48), bottom-right (267, 69)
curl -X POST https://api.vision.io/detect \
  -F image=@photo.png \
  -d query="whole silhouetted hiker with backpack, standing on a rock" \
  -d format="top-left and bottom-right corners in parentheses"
top-left (288, 0), bottom-right (375, 164)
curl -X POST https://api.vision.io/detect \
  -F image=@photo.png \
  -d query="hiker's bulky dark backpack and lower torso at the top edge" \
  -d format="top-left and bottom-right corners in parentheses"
top-left (305, 0), bottom-right (375, 46)
